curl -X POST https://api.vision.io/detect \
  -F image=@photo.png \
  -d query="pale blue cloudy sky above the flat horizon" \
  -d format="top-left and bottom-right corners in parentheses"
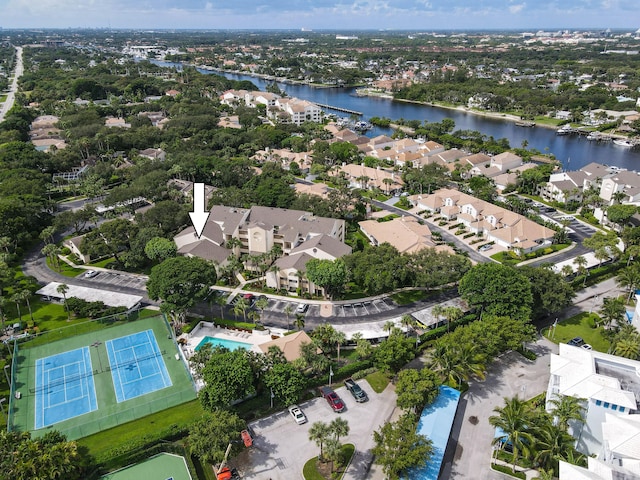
top-left (0, 0), bottom-right (640, 31)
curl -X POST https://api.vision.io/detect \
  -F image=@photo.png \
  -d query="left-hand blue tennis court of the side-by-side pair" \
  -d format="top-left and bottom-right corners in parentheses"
top-left (32, 347), bottom-right (98, 430)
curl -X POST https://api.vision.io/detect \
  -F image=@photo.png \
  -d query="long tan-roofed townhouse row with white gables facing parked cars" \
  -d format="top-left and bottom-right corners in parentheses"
top-left (416, 189), bottom-right (555, 253)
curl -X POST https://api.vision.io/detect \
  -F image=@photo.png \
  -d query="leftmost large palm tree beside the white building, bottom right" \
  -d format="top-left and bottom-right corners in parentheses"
top-left (489, 396), bottom-right (533, 472)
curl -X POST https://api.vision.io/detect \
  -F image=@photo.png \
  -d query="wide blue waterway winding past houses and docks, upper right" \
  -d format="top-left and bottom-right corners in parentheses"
top-left (155, 62), bottom-right (640, 171)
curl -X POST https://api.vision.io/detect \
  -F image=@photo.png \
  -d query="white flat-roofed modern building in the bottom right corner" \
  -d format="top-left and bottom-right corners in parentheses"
top-left (546, 343), bottom-right (640, 474)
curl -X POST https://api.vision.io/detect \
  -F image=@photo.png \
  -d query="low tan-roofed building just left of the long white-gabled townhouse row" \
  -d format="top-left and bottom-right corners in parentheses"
top-left (358, 216), bottom-right (453, 253)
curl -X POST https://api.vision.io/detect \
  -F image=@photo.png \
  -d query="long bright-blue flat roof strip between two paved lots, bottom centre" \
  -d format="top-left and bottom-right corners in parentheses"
top-left (409, 385), bottom-right (460, 480)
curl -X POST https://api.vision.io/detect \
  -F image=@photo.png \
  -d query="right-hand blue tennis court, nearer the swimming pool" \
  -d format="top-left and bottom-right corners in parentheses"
top-left (105, 330), bottom-right (172, 403)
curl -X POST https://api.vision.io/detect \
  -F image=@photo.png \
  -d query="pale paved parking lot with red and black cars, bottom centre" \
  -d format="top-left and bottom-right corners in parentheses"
top-left (231, 380), bottom-right (396, 480)
